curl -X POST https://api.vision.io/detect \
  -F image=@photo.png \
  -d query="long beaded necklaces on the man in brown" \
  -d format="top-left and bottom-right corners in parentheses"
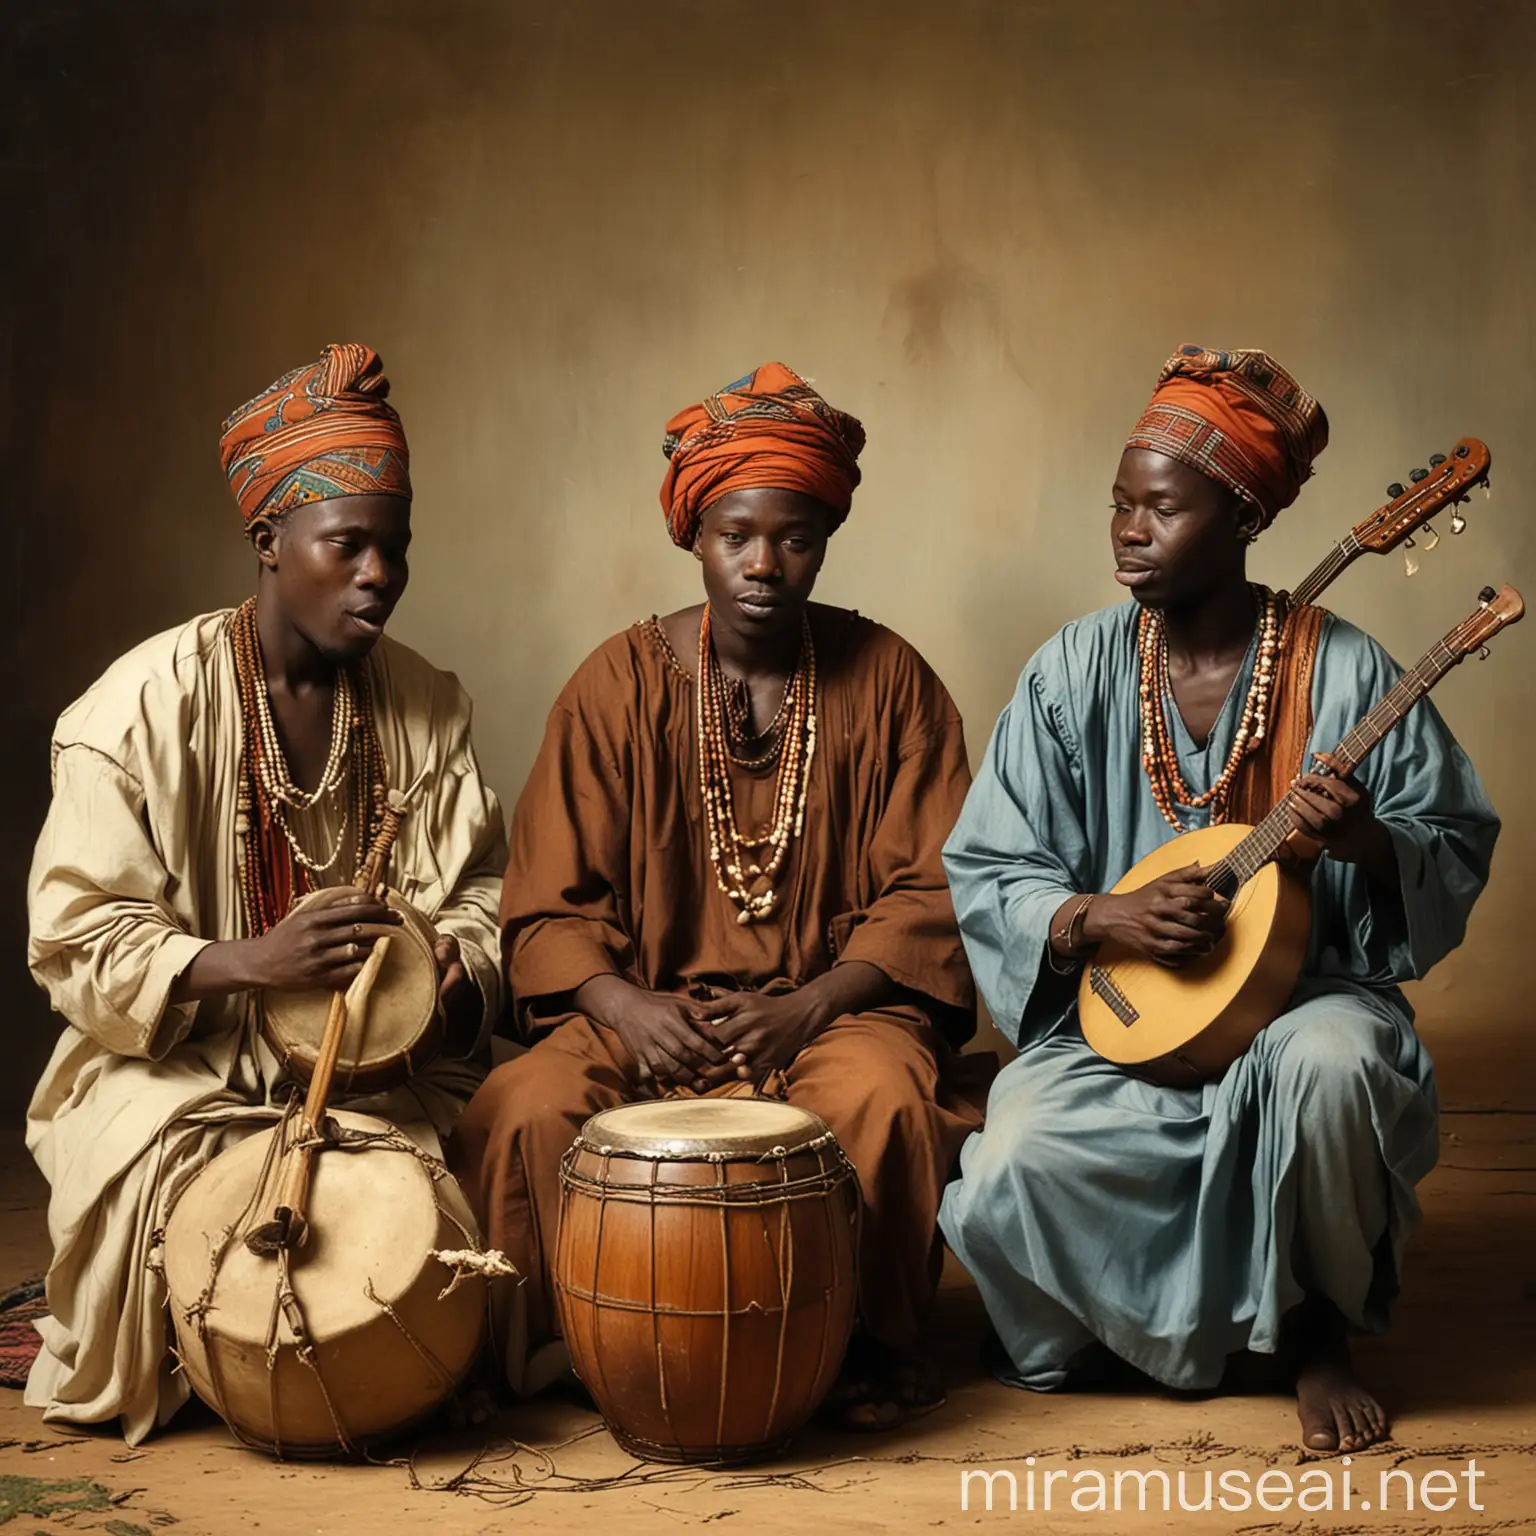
top-left (696, 604), bottom-right (816, 923)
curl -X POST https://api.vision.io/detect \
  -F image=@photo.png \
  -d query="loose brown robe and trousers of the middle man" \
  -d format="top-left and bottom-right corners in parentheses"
top-left (450, 605), bottom-right (978, 1375)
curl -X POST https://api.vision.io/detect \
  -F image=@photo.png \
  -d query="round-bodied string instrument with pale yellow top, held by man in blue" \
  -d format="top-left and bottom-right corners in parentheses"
top-left (1078, 587), bottom-right (1525, 1087)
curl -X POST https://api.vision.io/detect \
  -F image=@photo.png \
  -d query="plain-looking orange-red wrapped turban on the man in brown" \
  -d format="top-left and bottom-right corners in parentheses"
top-left (662, 362), bottom-right (865, 550)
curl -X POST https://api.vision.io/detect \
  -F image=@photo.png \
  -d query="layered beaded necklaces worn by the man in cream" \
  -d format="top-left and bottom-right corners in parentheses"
top-left (229, 598), bottom-right (389, 934)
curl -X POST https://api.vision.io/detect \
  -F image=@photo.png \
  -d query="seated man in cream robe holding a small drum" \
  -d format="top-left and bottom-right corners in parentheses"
top-left (26, 346), bottom-right (505, 1444)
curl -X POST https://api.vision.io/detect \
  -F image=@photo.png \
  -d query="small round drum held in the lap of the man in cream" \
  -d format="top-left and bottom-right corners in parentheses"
top-left (261, 885), bottom-right (442, 1094)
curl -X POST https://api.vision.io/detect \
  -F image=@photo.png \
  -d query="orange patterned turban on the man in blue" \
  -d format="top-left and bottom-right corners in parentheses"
top-left (1126, 346), bottom-right (1329, 528)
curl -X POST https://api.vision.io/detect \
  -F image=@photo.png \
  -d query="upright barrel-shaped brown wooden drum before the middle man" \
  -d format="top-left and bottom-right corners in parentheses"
top-left (553, 1098), bottom-right (860, 1464)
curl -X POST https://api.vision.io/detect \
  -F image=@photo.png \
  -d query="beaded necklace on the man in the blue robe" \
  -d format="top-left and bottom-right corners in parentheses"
top-left (1137, 585), bottom-right (1279, 833)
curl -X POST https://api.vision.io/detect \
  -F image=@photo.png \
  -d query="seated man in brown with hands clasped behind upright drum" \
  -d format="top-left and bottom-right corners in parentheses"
top-left (450, 364), bottom-right (975, 1427)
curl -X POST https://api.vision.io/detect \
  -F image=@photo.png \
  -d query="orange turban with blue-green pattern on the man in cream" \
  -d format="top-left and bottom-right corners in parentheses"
top-left (218, 341), bottom-right (410, 525)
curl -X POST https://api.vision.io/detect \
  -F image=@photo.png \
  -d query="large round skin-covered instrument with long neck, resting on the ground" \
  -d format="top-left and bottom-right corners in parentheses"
top-left (164, 793), bottom-right (488, 1456)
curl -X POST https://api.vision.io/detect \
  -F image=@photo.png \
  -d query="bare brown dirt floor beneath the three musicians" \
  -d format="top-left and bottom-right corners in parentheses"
top-left (0, 1111), bottom-right (1536, 1536)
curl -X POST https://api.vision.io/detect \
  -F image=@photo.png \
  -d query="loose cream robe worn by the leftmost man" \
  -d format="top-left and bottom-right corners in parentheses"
top-left (26, 611), bottom-right (507, 1444)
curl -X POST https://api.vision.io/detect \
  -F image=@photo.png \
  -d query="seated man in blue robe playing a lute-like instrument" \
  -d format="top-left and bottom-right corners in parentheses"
top-left (942, 347), bottom-right (1498, 1450)
